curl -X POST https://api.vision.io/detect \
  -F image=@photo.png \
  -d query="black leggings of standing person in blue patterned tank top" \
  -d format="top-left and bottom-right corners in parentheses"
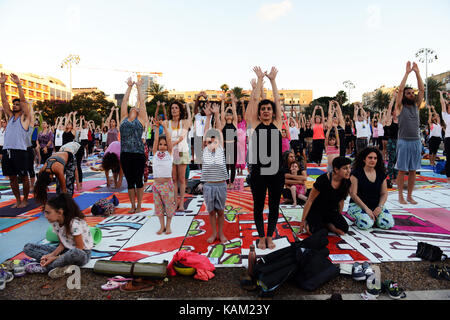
top-left (120, 152), bottom-right (145, 190)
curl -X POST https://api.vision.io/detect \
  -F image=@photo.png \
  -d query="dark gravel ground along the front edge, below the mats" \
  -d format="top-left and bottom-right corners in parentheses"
top-left (0, 260), bottom-right (450, 300)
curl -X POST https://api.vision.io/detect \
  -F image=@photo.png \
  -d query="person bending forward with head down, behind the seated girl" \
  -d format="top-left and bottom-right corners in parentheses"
top-left (34, 142), bottom-right (80, 204)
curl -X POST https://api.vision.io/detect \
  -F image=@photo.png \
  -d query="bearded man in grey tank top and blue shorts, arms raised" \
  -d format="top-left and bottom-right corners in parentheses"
top-left (395, 61), bottom-right (425, 204)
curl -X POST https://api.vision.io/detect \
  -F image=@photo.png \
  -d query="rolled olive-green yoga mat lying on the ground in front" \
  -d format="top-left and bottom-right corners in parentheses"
top-left (94, 260), bottom-right (168, 278)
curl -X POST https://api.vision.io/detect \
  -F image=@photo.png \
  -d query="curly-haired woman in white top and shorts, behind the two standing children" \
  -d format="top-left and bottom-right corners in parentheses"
top-left (164, 101), bottom-right (192, 211)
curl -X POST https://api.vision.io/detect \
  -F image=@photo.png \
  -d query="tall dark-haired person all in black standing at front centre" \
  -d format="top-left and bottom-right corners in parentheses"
top-left (246, 67), bottom-right (285, 249)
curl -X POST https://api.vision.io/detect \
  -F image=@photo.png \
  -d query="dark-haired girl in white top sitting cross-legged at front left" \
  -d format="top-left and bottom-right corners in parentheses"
top-left (23, 193), bottom-right (94, 278)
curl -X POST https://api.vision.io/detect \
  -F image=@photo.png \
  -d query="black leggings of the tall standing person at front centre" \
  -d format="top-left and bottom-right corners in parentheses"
top-left (250, 172), bottom-right (284, 238)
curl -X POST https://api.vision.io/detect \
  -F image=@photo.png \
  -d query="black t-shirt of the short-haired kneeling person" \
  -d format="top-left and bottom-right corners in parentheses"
top-left (309, 173), bottom-right (350, 214)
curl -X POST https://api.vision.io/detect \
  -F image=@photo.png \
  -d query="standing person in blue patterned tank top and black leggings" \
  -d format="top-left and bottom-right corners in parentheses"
top-left (120, 78), bottom-right (148, 213)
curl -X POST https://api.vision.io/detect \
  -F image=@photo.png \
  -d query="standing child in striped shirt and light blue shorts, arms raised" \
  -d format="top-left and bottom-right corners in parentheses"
top-left (202, 104), bottom-right (228, 243)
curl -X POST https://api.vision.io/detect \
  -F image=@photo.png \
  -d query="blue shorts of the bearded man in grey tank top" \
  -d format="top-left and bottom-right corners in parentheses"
top-left (395, 139), bottom-right (422, 171)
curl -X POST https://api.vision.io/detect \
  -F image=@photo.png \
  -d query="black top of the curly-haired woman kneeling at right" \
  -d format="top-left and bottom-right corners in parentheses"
top-left (350, 168), bottom-right (386, 211)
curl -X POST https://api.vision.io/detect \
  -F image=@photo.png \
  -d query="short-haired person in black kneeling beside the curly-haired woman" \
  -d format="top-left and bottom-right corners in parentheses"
top-left (300, 157), bottom-right (352, 236)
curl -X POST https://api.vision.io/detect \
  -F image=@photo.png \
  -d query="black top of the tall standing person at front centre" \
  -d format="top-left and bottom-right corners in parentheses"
top-left (251, 122), bottom-right (283, 174)
